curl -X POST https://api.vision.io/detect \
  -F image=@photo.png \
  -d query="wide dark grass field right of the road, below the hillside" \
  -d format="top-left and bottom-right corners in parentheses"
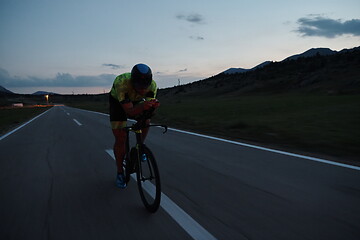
top-left (155, 94), bottom-right (360, 160)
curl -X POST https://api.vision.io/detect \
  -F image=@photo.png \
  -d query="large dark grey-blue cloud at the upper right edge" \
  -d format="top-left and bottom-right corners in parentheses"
top-left (296, 15), bottom-right (360, 38)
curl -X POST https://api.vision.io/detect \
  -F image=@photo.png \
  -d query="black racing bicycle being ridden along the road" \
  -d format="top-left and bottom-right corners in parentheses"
top-left (123, 113), bottom-right (167, 213)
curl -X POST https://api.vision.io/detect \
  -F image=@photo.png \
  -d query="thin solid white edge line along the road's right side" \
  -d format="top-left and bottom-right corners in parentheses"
top-left (75, 109), bottom-right (360, 171)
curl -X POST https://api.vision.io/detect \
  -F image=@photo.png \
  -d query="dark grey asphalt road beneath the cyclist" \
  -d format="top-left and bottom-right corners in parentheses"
top-left (0, 107), bottom-right (360, 240)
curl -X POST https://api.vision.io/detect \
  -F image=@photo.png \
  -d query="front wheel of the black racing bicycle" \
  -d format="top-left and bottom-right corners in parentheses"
top-left (136, 145), bottom-right (161, 213)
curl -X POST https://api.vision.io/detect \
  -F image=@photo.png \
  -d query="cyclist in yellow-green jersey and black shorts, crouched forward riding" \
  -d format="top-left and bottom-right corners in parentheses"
top-left (109, 63), bottom-right (160, 188)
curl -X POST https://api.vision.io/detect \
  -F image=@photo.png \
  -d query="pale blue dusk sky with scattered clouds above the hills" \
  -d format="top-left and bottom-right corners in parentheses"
top-left (0, 0), bottom-right (360, 94)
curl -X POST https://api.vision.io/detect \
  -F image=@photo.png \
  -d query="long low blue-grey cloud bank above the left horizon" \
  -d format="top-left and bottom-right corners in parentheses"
top-left (0, 68), bottom-right (116, 87)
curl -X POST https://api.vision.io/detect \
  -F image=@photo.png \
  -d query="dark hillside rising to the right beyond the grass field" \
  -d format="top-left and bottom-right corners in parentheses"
top-left (159, 47), bottom-right (360, 97)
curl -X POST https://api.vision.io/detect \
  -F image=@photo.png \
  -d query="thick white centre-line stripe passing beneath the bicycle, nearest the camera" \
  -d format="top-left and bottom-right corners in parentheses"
top-left (105, 149), bottom-right (216, 240)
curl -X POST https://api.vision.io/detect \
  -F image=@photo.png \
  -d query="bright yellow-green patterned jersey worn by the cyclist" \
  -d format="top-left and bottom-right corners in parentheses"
top-left (110, 73), bottom-right (157, 104)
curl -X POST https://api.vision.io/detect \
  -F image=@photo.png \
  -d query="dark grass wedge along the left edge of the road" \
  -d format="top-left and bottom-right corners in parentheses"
top-left (0, 107), bottom-right (50, 135)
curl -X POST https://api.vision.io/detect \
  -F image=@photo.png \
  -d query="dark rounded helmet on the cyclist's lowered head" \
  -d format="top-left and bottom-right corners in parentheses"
top-left (131, 63), bottom-right (152, 89)
